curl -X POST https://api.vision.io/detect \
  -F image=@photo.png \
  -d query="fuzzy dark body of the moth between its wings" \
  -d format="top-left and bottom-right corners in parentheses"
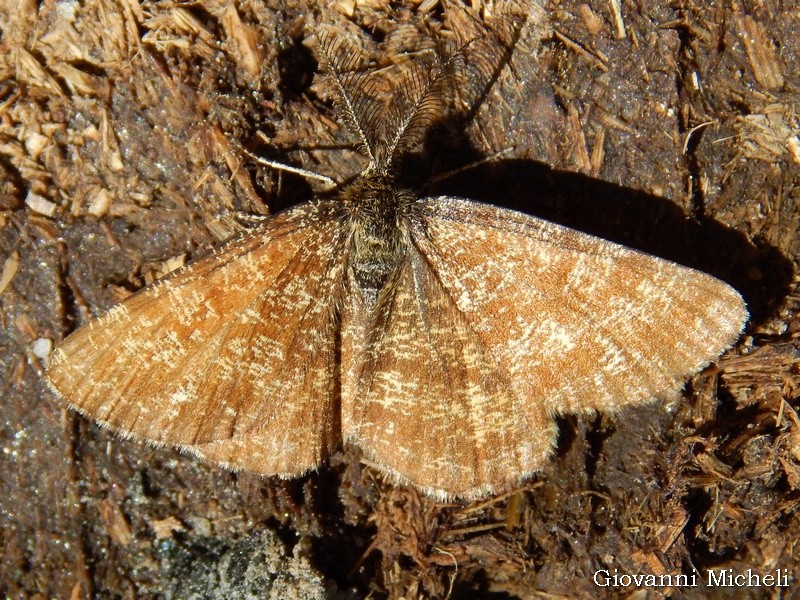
top-left (342, 173), bottom-right (414, 305)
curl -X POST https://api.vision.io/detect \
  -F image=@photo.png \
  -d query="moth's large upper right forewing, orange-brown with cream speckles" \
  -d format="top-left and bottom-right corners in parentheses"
top-left (413, 197), bottom-right (747, 424)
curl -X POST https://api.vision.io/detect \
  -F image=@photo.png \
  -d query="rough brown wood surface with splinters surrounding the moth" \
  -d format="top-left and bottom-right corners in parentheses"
top-left (0, 0), bottom-right (800, 598)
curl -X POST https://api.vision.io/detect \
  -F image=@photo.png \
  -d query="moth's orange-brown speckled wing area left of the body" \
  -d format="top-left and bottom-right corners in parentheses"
top-left (48, 203), bottom-right (344, 475)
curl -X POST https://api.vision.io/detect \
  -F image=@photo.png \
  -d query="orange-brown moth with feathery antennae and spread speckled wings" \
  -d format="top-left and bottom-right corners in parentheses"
top-left (48, 25), bottom-right (748, 499)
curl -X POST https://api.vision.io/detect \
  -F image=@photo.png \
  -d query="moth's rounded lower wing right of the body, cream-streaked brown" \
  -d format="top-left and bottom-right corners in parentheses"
top-left (342, 245), bottom-right (556, 498)
